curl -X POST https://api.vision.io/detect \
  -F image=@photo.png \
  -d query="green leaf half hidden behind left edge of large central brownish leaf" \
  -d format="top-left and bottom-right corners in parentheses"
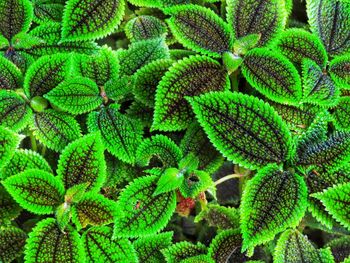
top-left (133, 59), bottom-right (173, 107)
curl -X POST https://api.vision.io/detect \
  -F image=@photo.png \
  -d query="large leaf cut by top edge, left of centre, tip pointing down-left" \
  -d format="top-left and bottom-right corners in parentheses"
top-left (62, 0), bottom-right (125, 41)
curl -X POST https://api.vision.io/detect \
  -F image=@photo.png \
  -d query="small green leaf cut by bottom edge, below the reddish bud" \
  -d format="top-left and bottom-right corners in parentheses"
top-left (162, 241), bottom-right (207, 263)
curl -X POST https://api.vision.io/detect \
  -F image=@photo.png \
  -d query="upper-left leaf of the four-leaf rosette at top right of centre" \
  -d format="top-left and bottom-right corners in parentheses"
top-left (163, 5), bottom-right (233, 57)
